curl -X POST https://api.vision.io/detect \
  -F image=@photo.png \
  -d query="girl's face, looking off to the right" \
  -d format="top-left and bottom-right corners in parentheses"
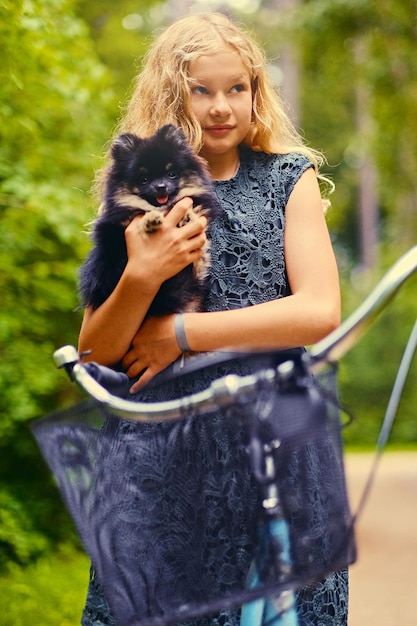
top-left (188, 46), bottom-right (252, 163)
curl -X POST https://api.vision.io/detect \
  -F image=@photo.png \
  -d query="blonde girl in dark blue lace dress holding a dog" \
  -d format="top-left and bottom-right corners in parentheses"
top-left (79, 9), bottom-right (347, 626)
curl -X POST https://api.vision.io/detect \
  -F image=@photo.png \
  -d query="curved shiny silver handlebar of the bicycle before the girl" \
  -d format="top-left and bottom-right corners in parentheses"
top-left (54, 246), bottom-right (417, 422)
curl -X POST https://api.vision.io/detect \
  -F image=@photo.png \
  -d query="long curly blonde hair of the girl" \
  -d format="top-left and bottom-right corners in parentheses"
top-left (96, 13), bottom-right (330, 197)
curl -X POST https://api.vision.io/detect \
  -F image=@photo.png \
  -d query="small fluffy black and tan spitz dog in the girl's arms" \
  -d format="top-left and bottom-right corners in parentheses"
top-left (79, 124), bottom-right (221, 315)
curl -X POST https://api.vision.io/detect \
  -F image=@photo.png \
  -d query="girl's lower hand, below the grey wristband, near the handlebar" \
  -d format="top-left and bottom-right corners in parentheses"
top-left (122, 315), bottom-right (181, 393)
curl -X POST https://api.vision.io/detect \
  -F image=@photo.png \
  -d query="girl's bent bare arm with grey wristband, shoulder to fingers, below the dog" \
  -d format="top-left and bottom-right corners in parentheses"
top-left (123, 169), bottom-right (341, 391)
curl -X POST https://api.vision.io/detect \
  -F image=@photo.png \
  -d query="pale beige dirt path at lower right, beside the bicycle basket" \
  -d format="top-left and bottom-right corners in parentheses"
top-left (346, 452), bottom-right (417, 626)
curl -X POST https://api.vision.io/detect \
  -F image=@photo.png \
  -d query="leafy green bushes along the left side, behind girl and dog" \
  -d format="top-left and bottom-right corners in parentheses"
top-left (0, 0), bottom-right (112, 565)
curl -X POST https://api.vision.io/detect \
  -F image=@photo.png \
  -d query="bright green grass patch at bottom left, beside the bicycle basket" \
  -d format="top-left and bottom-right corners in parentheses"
top-left (0, 548), bottom-right (89, 626)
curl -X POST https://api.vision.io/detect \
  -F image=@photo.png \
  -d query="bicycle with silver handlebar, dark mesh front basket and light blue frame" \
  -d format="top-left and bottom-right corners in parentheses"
top-left (32, 246), bottom-right (417, 626)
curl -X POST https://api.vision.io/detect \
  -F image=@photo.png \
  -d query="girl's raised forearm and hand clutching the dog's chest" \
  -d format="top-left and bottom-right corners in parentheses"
top-left (78, 198), bottom-right (207, 365)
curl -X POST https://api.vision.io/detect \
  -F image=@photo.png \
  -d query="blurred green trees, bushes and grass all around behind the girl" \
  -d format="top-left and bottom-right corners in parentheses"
top-left (0, 0), bottom-right (417, 626)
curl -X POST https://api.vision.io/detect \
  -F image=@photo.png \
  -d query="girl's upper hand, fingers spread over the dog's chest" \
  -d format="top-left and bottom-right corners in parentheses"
top-left (125, 198), bottom-right (207, 291)
